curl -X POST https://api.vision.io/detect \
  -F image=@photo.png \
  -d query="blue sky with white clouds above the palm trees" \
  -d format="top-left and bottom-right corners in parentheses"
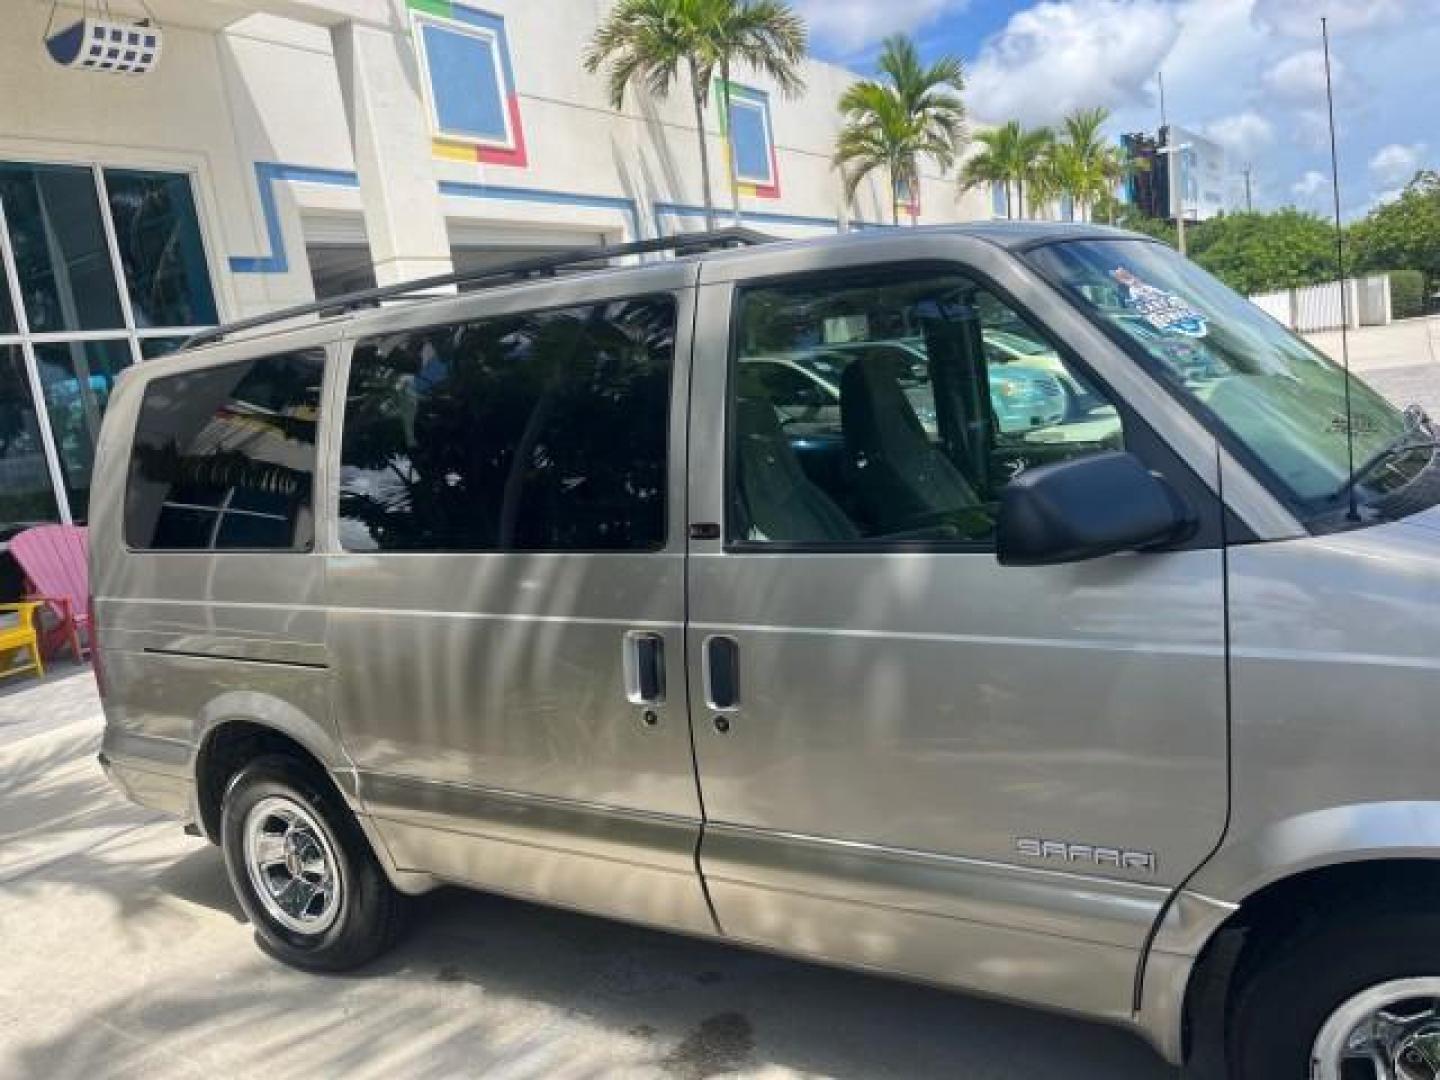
top-left (792, 0), bottom-right (1440, 217)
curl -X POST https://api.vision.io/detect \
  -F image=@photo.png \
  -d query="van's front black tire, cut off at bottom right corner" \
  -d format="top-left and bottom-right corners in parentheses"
top-left (1225, 906), bottom-right (1440, 1080)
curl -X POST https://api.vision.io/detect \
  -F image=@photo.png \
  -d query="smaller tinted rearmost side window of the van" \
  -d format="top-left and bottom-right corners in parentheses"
top-left (125, 348), bottom-right (325, 552)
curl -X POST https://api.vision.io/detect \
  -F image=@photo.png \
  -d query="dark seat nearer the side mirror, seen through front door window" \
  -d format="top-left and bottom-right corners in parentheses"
top-left (840, 356), bottom-right (981, 533)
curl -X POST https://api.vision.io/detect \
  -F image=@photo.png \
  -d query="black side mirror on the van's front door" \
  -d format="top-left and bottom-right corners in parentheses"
top-left (995, 451), bottom-right (1195, 566)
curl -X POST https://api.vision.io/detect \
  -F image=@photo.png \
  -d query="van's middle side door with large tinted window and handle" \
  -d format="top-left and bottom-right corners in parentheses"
top-left (328, 265), bottom-right (713, 932)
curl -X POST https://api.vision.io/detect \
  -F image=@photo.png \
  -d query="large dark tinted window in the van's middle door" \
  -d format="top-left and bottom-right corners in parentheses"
top-left (340, 297), bottom-right (675, 552)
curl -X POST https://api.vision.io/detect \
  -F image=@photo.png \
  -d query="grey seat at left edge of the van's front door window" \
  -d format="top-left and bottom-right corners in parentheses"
top-left (734, 397), bottom-right (860, 541)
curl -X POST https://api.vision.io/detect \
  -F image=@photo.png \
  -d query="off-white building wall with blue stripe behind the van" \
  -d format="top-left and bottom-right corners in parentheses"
top-left (0, 0), bottom-right (991, 325)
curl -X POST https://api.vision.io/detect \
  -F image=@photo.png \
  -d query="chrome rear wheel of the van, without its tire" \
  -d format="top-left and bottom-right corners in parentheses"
top-left (243, 795), bottom-right (344, 935)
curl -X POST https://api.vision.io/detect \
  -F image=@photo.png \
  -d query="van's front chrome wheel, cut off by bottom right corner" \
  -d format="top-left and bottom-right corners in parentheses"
top-left (1310, 976), bottom-right (1440, 1080)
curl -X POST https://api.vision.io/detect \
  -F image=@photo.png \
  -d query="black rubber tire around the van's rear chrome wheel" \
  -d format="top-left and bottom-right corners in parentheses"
top-left (220, 755), bottom-right (405, 972)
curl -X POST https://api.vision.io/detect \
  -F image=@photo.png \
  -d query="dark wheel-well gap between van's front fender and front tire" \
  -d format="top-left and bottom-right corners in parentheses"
top-left (1184, 857), bottom-right (1440, 1080)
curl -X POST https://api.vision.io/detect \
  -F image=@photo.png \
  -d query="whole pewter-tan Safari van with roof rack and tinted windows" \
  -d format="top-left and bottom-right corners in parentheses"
top-left (91, 225), bottom-right (1440, 1080)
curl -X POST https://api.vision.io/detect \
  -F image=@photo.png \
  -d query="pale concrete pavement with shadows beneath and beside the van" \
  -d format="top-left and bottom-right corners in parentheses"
top-left (0, 670), bottom-right (1175, 1080)
